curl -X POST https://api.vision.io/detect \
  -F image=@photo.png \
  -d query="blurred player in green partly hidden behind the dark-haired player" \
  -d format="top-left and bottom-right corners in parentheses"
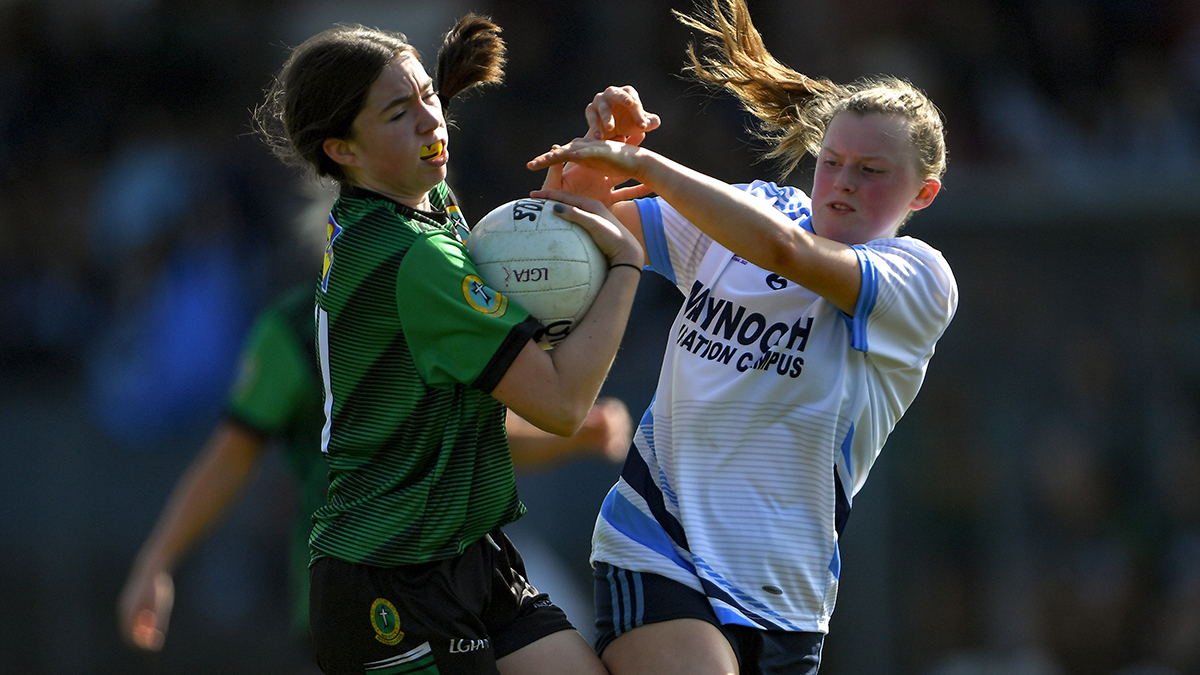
top-left (118, 278), bottom-right (632, 651)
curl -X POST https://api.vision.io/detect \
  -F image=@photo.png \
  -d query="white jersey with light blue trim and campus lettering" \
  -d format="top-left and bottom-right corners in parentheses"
top-left (592, 181), bottom-right (958, 633)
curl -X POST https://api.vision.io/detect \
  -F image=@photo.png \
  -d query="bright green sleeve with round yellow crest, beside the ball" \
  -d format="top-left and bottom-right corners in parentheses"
top-left (396, 232), bottom-right (541, 392)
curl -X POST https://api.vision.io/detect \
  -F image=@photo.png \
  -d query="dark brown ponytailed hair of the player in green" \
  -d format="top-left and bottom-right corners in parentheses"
top-left (254, 14), bottom-right (505, 180)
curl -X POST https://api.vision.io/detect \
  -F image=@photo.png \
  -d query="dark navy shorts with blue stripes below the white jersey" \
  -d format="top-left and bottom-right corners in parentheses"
top-left (593, 562), bottom-right (824, 675)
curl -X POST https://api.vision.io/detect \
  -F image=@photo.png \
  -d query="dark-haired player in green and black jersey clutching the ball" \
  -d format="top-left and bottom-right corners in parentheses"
top-left (257, 16), bottom-right (644, 675)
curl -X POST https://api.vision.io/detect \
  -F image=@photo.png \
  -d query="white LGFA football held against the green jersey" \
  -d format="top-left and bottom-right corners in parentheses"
top-left (467, 198), bottom-right (608, 348)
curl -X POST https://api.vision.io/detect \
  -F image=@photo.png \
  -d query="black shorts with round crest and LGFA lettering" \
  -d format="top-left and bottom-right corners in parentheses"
top-left (308, 528), bottom-right (572, 675)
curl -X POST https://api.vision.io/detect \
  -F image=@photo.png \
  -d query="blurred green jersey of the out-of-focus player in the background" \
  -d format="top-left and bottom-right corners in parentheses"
top-left (226, 283), bottom-right (329, 634)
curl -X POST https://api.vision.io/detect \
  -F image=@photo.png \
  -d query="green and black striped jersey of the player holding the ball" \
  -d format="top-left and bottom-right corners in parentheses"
top-left (310, 183), bottom-right (540, 567)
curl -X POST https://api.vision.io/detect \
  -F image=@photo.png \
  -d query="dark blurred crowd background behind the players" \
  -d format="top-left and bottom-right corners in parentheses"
top-left (0, 0), bottom-right (1200, 675)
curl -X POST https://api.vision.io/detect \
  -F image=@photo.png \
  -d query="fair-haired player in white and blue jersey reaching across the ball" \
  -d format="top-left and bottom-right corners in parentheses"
top-left (529, 0), bottom-right (958, 675)
